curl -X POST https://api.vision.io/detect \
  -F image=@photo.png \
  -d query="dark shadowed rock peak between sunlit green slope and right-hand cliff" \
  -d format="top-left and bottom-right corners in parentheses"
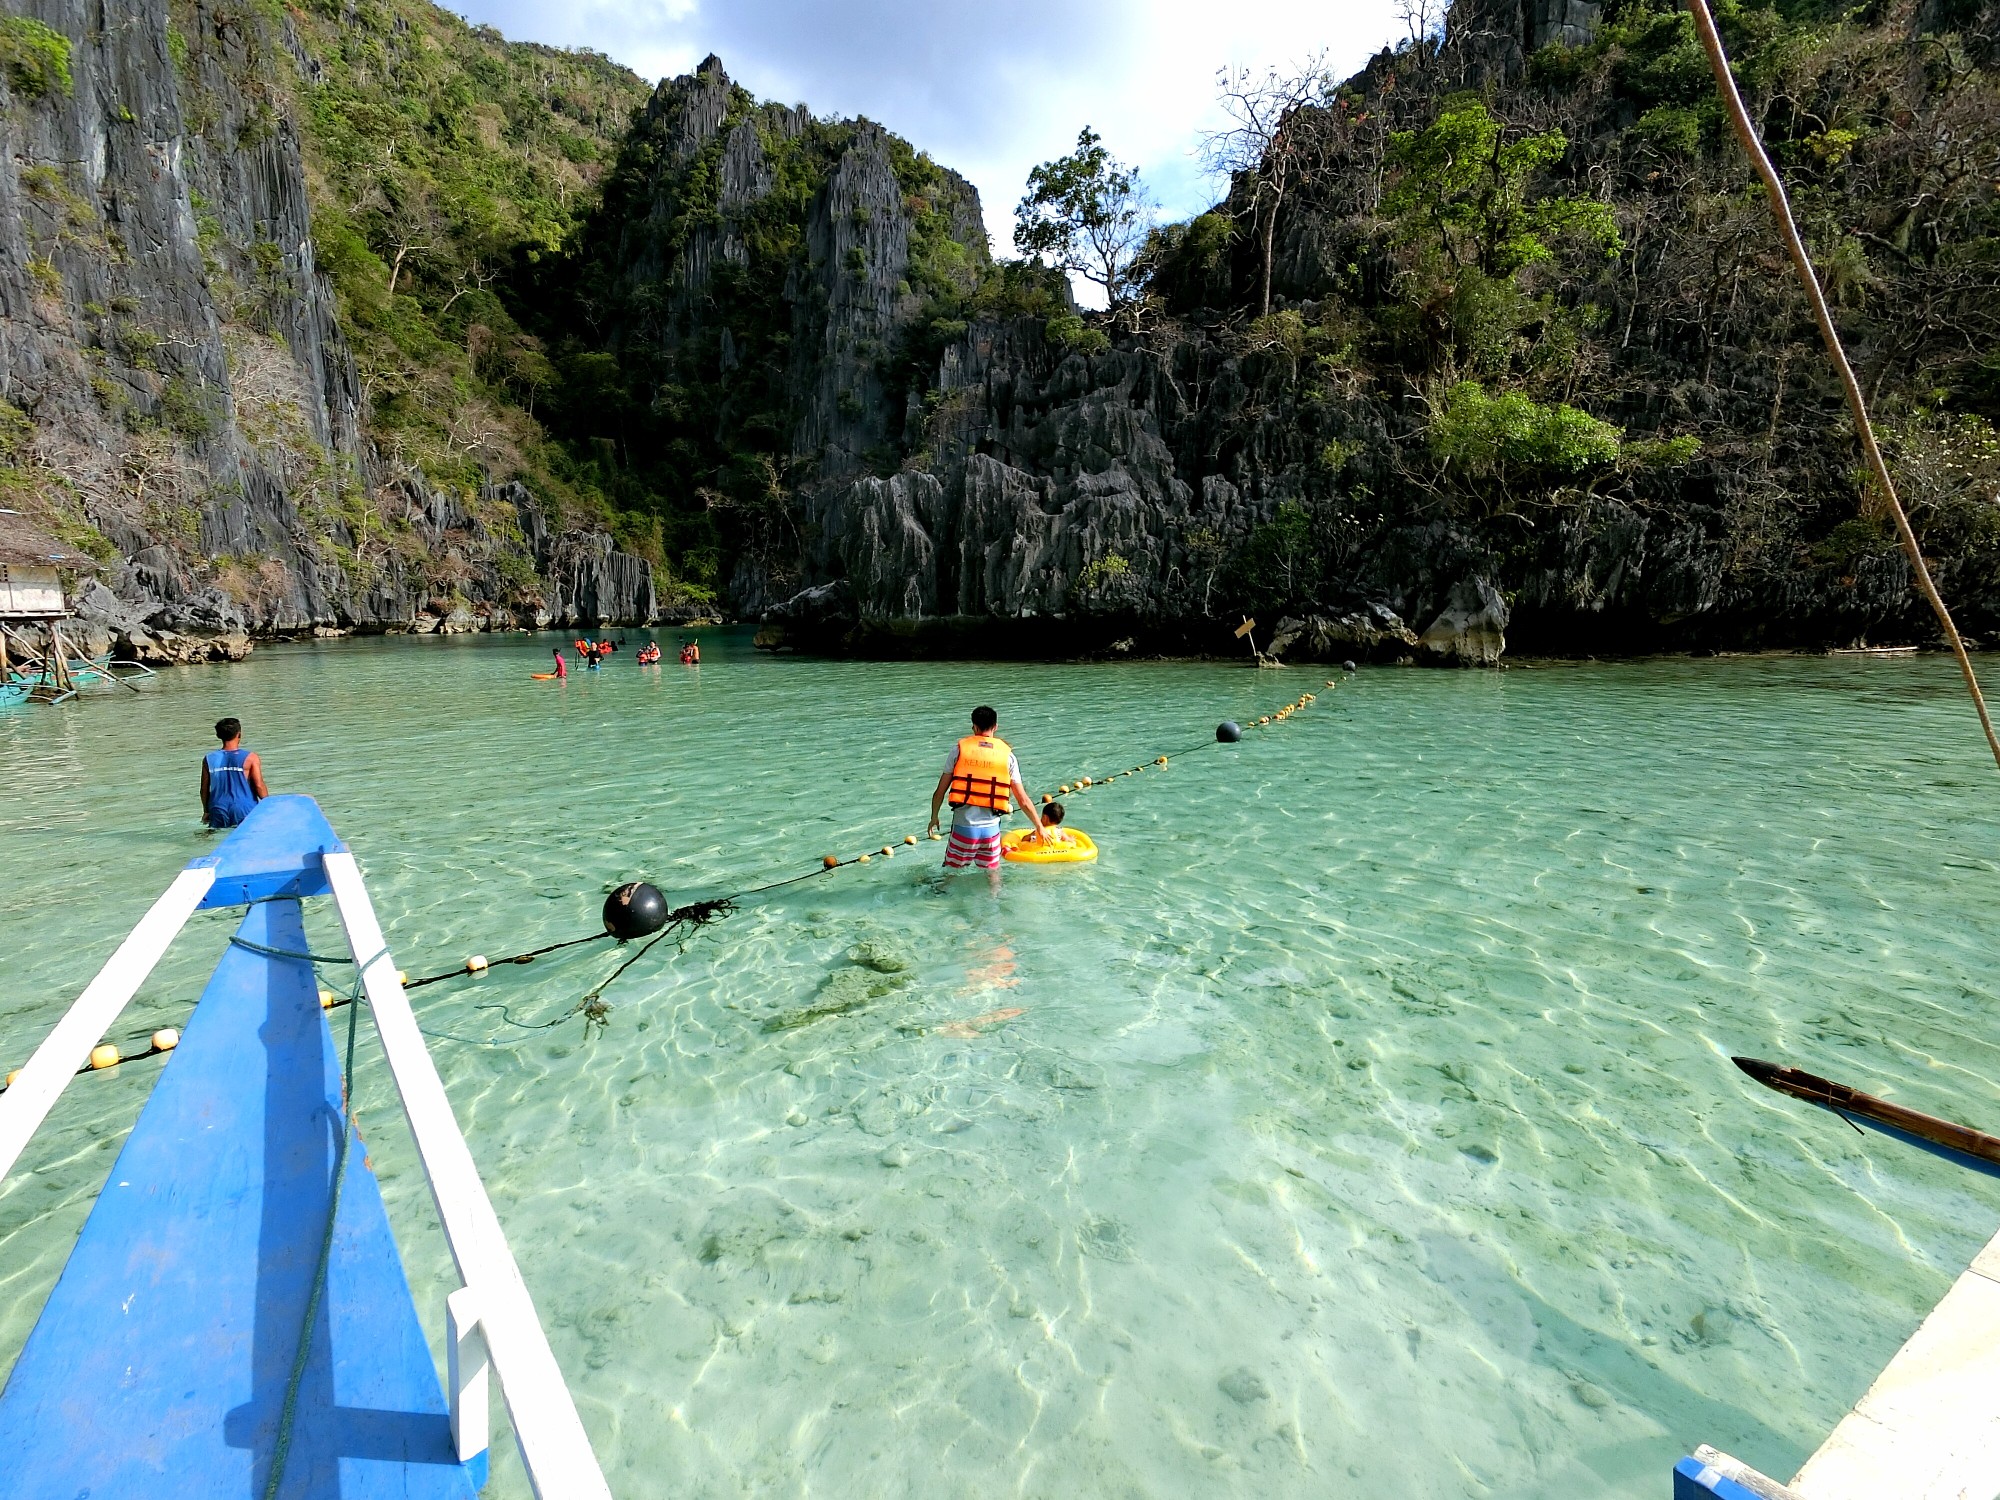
top-left (544, 58), bottom-right (990, 606)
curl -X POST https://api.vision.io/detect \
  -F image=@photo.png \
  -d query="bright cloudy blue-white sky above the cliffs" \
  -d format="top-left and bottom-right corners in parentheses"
top-left (448, 0), bottom-right (1402, 280)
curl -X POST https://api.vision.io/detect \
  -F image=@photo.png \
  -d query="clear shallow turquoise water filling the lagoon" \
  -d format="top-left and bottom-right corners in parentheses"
top-left (0, 636), bottom-right (2000, 1498)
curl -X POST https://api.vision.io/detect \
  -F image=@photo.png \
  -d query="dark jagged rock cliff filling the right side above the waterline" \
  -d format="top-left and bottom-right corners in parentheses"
top-left (738, 0), bottom-right (2000, 664)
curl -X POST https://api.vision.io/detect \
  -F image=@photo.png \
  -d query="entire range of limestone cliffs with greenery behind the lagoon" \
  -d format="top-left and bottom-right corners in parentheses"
top-left (15, 0), bottom-right (2000, 664)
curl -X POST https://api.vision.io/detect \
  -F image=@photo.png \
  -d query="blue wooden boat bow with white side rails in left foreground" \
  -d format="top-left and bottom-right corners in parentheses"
top-left (0, 796), bottom-right (610, 1500)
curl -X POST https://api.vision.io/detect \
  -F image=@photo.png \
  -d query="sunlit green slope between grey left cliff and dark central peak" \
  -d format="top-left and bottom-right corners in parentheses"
top-left (282, 0), bottom-right (646, 540)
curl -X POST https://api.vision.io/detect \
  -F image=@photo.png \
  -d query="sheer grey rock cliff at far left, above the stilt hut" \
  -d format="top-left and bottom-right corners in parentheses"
top-left (0, 0), bottom-right (652, 656)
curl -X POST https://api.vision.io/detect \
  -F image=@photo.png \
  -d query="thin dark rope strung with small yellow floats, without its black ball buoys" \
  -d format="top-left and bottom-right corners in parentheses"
top-left (0, 678), bottom-right (1340, 1094)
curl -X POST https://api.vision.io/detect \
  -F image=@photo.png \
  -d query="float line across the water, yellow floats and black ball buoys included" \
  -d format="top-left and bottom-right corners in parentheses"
top-left (0, 680), bottom-right (1354, 1094)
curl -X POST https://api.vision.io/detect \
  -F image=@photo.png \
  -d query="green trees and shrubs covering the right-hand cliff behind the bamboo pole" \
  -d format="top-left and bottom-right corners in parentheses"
top-left (1138, 0), bottom-right (2000, 628)
